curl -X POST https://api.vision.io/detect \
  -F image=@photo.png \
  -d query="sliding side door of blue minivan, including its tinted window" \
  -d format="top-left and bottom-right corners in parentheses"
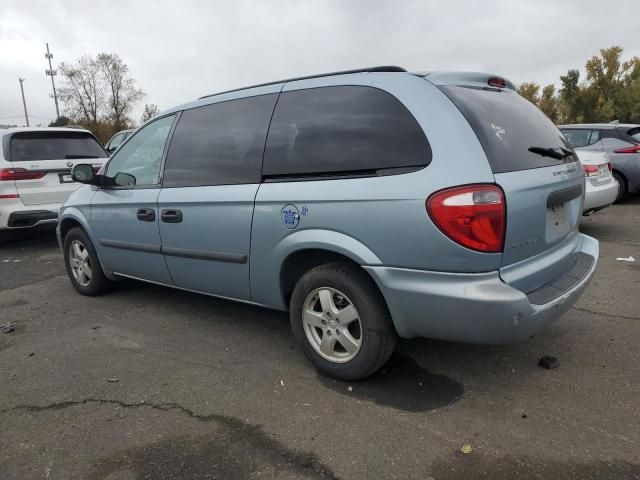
top-left (158, 91), bottom-right (281, 300)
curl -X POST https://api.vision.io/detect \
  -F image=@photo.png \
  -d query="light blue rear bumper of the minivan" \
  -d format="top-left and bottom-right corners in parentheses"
top-left (365, 235), bottom-right (599, 345)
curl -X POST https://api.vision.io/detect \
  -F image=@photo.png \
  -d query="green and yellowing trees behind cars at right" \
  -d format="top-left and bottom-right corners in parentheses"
top-left (518, 46), bottom-right (640, 123)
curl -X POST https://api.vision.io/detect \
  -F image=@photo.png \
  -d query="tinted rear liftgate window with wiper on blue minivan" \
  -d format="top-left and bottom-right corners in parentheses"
top-left (439, 85), bottom-right (576, 173)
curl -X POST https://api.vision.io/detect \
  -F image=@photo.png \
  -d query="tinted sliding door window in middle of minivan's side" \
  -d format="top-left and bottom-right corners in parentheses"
top-left (162, 94), bottom-right (277, 187)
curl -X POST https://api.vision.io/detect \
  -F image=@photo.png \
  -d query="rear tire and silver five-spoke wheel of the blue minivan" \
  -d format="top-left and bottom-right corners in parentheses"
top-left (290, 262), bottom-right (396, 380)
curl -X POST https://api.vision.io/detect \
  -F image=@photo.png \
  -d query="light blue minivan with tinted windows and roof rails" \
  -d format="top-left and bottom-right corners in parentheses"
top-left (58, 67), bottom-right (598, 379)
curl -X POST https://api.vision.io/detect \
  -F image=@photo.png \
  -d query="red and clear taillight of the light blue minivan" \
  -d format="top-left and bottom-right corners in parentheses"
top-left (427, 185), bottom-right (507, 253)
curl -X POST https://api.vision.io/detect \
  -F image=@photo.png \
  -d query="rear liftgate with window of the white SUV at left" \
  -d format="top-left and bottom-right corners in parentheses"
top-left (8, 130), bottom-right (108, 205)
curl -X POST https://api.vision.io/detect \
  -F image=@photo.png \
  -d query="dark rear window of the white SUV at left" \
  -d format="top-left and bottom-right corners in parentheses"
top-left (10, 132), bottom-right (109, 162)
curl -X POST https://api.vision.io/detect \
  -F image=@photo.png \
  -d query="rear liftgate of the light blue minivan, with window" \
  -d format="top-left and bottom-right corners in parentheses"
top-left (440, 85), bottom-right (584, 290)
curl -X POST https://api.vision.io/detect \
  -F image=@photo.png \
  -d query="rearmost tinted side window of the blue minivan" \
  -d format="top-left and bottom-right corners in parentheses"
top-left (263, 86), bottom-right (431, 175)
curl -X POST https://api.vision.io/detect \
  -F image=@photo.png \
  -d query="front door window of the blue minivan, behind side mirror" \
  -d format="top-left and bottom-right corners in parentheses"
top-left (106, 115), bottom-right (175, 186)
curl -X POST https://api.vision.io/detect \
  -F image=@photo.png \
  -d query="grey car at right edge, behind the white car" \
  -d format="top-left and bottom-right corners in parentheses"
top-left (558, 122), bottom-right (640, 201)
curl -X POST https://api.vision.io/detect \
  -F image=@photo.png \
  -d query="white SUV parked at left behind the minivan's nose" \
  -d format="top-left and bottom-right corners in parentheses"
top-left (0, 127), bottom-right (109, 230)
